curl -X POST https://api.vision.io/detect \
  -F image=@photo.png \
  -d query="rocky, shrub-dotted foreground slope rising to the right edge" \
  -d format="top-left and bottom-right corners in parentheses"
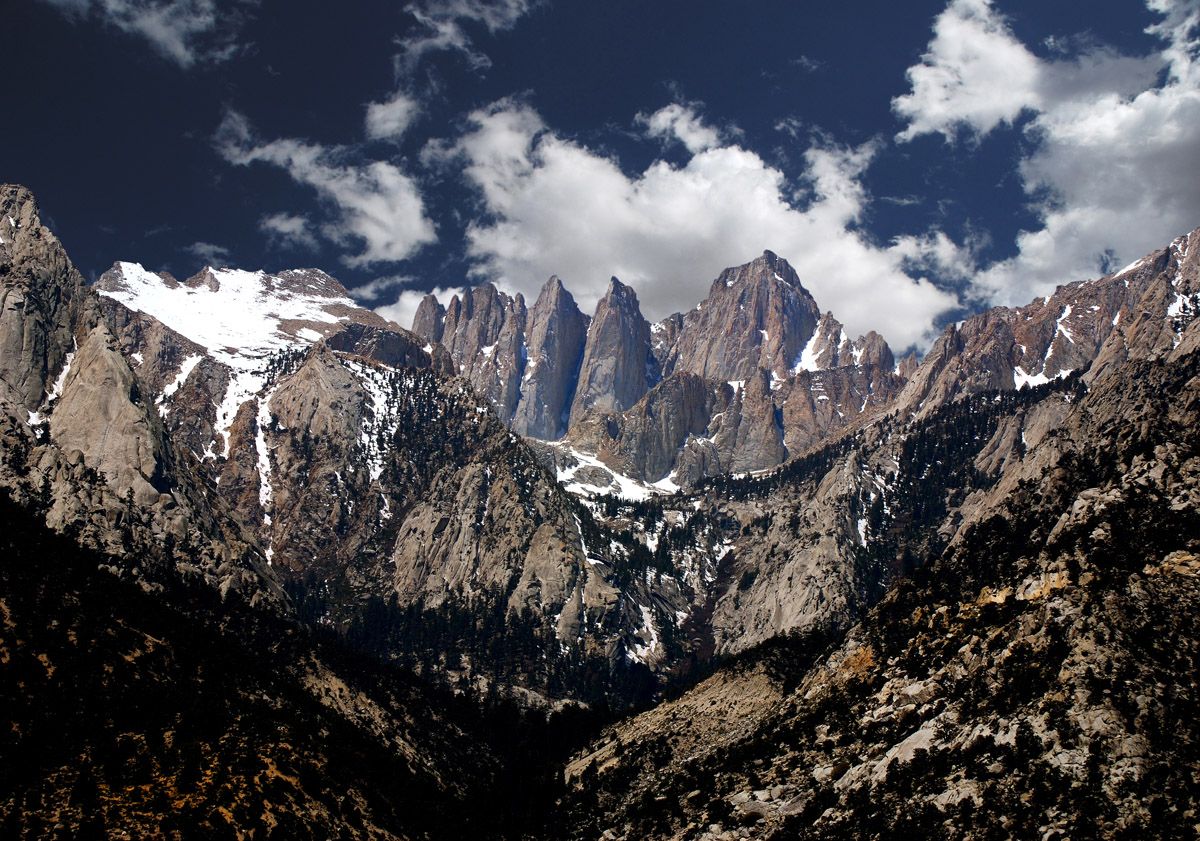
top-left (560, 338), bottom-right (1200, 839)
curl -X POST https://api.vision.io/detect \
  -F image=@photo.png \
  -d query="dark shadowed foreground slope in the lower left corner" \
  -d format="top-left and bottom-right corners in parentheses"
top-left (0, 498), bottom-right (520, 839)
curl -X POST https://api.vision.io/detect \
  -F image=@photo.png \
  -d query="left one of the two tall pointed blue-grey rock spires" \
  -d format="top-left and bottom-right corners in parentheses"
top-left (512, 277), bottom-right (588, 440)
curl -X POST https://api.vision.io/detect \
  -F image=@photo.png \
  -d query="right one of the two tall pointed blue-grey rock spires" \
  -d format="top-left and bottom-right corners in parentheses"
top-left (570, 277), bottom-right (655, 426)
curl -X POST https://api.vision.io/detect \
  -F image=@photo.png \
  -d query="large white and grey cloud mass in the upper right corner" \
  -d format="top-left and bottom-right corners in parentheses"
top-left (893, 0), bottom-right (1200, 304)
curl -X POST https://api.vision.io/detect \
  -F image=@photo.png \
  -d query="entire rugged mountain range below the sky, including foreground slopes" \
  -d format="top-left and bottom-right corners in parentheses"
top-left (0, 179), bottom-right (1200, 839)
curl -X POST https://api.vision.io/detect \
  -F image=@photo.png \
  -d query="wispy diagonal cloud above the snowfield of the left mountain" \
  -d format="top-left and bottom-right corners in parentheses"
top-left (216, 112), bottom-right (437, 266)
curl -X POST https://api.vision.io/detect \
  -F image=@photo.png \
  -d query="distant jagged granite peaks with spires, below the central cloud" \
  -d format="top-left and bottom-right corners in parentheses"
top-left (414, 252), bottom-right (906, 493)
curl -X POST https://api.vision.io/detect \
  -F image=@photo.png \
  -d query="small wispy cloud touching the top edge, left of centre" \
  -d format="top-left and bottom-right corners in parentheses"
top-left (396, 0), bottom-right (536, 73)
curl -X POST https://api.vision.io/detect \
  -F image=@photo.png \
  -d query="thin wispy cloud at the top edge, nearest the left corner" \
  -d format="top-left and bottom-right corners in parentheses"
top-left (43, 0), bottom-right (250, 68)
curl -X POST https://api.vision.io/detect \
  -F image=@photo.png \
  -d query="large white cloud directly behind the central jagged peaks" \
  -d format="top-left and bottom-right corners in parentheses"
top-left (427, 101), bottom-right (956, 347)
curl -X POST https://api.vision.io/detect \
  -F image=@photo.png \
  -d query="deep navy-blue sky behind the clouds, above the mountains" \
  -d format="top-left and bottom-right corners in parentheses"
top-left (0, 0), bottom-right (1200, 343)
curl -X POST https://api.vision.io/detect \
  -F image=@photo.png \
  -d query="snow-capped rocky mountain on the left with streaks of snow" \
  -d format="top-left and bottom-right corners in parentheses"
top-left (4, 188), bottom-right (729, 705)
